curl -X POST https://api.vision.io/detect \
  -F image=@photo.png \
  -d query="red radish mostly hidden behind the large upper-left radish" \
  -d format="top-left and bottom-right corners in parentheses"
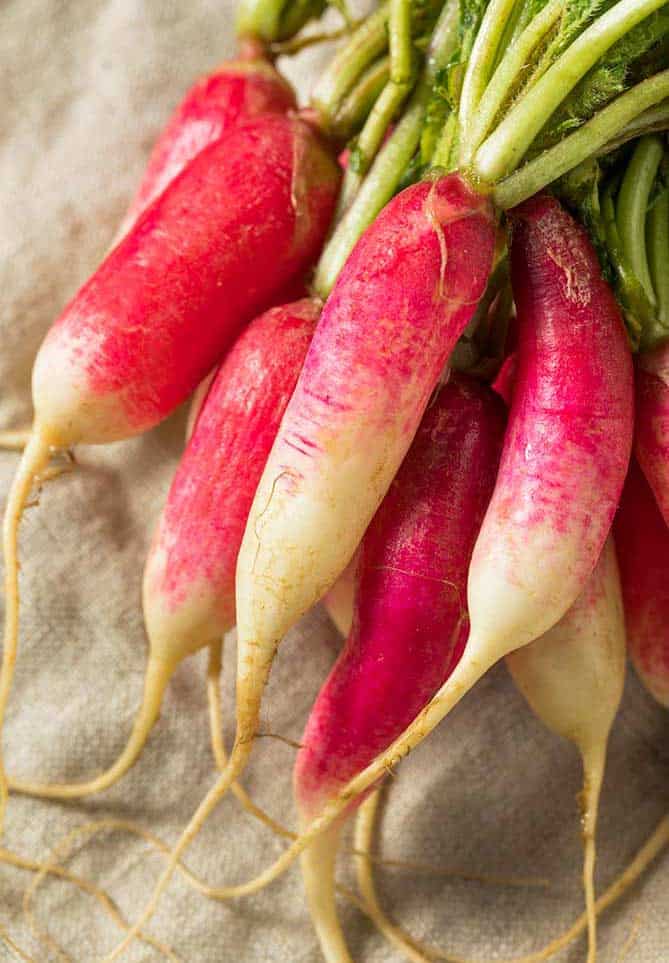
top-left (118, 59), bottom-right (297, 238)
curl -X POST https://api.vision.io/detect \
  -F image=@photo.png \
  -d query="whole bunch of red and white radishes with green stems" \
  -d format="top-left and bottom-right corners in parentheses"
top-left (0, 0), bottom-right (669, 963)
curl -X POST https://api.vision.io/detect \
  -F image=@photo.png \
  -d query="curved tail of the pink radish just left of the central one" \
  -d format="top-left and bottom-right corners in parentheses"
top-left (9, 658), bottom-right (176, 799)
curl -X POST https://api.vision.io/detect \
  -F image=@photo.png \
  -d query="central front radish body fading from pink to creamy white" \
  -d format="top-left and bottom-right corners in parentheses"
top-left (232, 176), bottom-right (495, 736)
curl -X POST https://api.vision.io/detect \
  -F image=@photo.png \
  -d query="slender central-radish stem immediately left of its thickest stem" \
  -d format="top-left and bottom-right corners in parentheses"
top-left (463, 0), bottom-right (565, 165)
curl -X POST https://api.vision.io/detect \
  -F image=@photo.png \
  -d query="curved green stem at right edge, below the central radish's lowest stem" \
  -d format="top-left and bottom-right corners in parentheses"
top-left (616, 135), bottom-right (664, 304)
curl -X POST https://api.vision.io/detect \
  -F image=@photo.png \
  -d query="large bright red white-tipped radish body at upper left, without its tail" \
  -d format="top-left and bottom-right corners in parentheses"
top-left (33, 115), bottom-right (339, 446)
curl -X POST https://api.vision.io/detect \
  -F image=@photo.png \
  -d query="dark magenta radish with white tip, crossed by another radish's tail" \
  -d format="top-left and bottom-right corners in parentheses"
top-left (295, 376), bottom-right (504, 961)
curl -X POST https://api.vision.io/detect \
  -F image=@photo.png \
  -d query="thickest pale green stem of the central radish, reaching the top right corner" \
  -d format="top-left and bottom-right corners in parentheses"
top-left (474, 0), bottom-right (667, 184)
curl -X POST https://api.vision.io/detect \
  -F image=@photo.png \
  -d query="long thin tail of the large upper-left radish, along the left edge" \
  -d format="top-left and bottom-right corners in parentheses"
top-left (0, 431), bottom-right (50, 838)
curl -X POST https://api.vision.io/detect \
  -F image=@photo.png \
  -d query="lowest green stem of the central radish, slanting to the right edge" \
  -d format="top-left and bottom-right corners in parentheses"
top-left (493, 70), bottom-right (669, 210)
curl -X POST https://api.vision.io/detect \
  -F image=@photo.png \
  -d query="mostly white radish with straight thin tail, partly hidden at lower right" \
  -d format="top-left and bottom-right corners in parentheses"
top-left (507, 537), bottom-right (625, 963)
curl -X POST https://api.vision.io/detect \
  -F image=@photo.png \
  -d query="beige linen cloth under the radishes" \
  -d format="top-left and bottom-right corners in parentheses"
top-left (0, 0), bottom-right (669, 963)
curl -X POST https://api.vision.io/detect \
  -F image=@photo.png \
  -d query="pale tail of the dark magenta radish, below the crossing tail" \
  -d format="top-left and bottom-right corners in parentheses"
top-left (300, 824), bottom-right (353, 963)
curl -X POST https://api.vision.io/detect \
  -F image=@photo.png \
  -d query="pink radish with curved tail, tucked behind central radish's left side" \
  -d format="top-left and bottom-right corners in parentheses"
top-left (10, 299), bottom-right (321, 799)
